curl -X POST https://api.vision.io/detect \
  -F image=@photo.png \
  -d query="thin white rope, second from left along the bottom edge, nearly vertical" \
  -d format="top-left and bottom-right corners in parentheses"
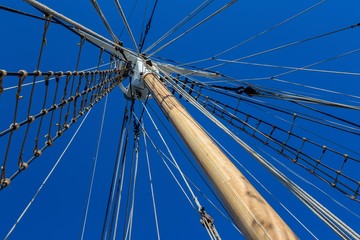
top-left (80, 94), bottom-right (108, 240)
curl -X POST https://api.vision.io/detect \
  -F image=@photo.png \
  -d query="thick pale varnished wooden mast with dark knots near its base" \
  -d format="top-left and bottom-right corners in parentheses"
top-left (143, 73), bottom-right (298, 240)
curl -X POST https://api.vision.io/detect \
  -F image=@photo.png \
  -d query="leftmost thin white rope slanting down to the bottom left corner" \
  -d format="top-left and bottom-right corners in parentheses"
top-left (5, 108), bottom-right (91, 240)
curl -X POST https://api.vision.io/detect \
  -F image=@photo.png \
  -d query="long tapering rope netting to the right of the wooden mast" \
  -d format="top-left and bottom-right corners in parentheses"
top-left (169, 77), bottom-right (360, 201)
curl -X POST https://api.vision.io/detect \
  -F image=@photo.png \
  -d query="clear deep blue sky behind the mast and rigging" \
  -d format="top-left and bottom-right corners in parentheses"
top-left (0, 0), bottom-right (360, 239)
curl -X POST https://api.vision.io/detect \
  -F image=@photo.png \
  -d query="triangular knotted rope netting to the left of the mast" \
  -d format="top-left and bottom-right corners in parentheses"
top-left (0, 68), bottom-right (126, 189)
